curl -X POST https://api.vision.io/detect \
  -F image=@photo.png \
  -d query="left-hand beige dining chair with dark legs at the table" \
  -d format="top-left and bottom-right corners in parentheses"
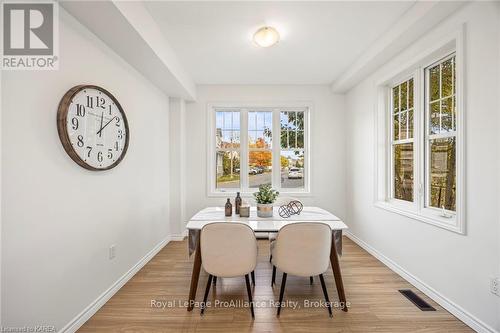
top-left (200, 222), bottom-right (257, 318)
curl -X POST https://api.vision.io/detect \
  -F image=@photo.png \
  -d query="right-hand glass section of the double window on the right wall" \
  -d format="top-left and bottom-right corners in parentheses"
top-left (425, 55), bottom-right (457, 211)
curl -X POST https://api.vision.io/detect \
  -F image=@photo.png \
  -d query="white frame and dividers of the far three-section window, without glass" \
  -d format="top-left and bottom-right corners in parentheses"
top-left (206, 102), bottom-right (313, 197)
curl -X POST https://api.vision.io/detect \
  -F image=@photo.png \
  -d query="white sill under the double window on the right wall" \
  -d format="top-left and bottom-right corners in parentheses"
top-left (375, 201), bottom-right (465, 235)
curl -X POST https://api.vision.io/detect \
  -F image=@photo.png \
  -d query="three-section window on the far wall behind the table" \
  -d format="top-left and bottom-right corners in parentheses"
top-left (208, 106), bottom-right (309, 195)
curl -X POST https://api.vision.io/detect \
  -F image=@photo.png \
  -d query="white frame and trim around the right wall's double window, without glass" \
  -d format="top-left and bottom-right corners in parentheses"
top-left (374, 25), bottom-right (466, 234)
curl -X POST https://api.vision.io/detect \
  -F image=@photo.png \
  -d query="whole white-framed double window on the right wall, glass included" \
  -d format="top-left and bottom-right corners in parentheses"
top-left (375, 31), bottom-right (465, 233)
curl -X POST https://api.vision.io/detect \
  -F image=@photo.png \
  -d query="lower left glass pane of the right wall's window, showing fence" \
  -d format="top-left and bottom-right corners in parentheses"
top-left (393, 143), bottom-right (413, 201)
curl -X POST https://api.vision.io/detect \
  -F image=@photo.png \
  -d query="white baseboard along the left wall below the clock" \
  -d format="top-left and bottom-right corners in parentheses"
top-left (59, 236), bottom-right (172, 333)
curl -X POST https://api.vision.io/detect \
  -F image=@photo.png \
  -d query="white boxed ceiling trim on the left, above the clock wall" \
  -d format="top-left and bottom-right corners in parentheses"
top-left (60, 1), bottom-right (196, 101)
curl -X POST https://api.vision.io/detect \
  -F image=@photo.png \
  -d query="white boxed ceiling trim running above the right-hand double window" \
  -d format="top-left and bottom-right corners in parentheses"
top-left (331, 1), bottom-right (466, 93)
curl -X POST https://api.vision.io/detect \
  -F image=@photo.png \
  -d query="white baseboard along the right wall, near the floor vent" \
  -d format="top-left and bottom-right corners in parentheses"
top-left (345, 231), bottom-right (499, 333)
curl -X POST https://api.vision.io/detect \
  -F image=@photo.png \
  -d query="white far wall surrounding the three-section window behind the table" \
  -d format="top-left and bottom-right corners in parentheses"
top-left (186, 85), bottom-right (345, 227)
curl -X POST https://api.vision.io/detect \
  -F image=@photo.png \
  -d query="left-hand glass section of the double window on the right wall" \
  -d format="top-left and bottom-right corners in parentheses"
top-left (392, 78), bottom-right (414, 201)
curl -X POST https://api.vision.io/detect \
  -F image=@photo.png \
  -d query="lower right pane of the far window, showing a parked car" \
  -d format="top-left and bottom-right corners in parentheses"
top-left (280, 150), bottom-right (304, 188)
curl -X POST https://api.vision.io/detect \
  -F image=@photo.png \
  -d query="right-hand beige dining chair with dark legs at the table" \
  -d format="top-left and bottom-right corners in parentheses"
top-left (272, 222), bottom-right (332, 317)
